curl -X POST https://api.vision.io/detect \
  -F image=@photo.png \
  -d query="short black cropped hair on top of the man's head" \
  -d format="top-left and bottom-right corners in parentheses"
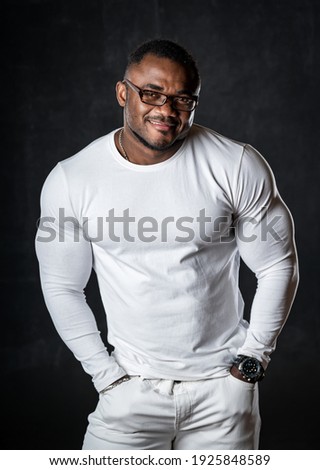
top-left (126, 39), bottom-right (200, 85)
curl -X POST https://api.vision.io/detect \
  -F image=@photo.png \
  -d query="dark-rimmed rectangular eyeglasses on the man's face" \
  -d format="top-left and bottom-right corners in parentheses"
top-left (123, 78), bottom-right (198, 112)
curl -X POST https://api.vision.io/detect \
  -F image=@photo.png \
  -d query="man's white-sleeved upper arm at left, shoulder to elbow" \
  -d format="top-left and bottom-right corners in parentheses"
top-left (35, 165), bottom-right (92, 290)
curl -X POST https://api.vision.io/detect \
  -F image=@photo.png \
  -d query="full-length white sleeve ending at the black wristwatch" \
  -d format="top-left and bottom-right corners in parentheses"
top-left (234, 145), bottom-right (299, 368)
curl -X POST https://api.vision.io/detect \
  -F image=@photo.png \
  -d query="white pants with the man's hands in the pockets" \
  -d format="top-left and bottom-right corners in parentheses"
top-left (82, 375), bottom-right (260, 450)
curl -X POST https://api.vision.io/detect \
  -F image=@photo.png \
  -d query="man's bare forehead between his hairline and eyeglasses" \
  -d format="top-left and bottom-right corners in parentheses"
top-left (126, 54), bottom-right (197, 93)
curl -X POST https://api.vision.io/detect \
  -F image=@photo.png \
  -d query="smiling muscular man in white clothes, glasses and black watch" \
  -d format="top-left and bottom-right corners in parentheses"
top-left (36, 40), bottom-right (298, 450)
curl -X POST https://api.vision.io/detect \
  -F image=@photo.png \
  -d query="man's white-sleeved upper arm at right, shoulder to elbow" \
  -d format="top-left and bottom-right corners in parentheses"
top-left (234, 146), bottom-right (295, 274)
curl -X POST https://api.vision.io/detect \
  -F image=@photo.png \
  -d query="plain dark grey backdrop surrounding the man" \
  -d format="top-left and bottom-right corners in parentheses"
top-left (0, 0), bottom-right (320, 449)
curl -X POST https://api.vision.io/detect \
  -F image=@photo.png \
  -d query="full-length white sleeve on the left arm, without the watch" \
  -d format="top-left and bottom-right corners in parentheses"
top-left (35, 164), bottom-right (126, 391)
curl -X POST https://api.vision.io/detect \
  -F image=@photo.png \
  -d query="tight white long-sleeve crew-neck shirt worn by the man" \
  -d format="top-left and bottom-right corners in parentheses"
top-left (36, 125), bottom-right (298, 391)
